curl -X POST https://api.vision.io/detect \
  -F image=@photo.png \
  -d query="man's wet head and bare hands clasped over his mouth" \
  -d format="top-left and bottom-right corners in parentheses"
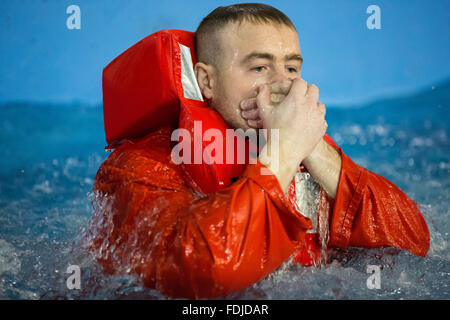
top-left (195, 4), bottom-right (341, 198)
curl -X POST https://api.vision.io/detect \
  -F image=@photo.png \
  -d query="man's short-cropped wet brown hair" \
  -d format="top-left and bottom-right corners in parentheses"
top-left (195, 3), bottom-right (295, 65)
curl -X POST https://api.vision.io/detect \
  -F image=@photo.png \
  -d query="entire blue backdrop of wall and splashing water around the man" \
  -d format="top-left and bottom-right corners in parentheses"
top-left (0, 0), bottom-right (450, 300)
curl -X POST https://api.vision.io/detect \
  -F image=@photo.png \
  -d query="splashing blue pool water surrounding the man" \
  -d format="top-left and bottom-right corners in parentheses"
top-left (0, 82), bottom-right (450, 299)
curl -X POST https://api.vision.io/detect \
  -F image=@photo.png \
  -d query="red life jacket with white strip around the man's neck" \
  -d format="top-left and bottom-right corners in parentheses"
top-left (103, 30), bottom-right (250, 194)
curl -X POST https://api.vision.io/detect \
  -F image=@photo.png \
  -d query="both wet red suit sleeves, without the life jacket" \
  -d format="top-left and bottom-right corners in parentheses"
top-left (91, 128), bottom-right (429, 298)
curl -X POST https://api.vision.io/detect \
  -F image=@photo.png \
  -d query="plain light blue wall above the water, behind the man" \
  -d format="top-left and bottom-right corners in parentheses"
top-left (0, 0), bottom-right (450, 105)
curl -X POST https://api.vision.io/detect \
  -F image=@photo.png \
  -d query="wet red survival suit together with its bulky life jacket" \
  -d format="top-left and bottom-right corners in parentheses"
top-left (90, 30), bottom-right (429, 298)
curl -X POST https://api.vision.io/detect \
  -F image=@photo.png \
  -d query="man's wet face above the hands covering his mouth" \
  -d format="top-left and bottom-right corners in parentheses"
top-left (210, 21), bottom-right (302, 130)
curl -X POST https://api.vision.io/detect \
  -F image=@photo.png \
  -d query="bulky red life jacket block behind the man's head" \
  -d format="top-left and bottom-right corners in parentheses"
top-left (102, 29), bottom-right (200, 148)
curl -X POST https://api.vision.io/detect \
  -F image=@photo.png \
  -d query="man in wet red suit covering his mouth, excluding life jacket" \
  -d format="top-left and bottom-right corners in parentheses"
top-left (91, 4), bottom-right (429, 298)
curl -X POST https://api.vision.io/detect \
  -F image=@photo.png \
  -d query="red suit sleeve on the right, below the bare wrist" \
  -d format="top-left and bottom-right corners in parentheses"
top-left (329, 146), bottom-right (430, 256)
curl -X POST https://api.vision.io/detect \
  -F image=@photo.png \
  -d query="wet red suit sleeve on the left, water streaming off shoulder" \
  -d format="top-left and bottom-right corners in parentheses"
top-left (91, 130), bottom-right (312, 298)
